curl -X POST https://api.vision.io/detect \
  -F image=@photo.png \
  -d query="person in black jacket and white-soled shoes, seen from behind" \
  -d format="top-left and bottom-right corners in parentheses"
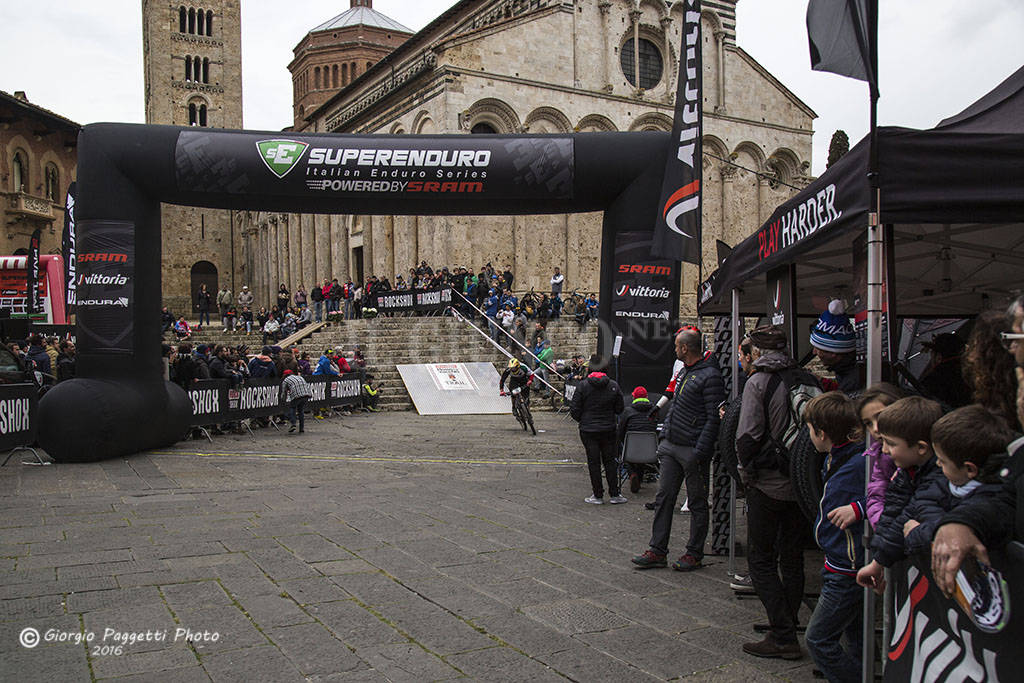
top-left (569, 355), bottom-right (626, 505)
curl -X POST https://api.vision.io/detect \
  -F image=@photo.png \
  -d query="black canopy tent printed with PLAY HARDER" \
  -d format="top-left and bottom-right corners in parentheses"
top-left (699, 67), bottom-right (1024, 327)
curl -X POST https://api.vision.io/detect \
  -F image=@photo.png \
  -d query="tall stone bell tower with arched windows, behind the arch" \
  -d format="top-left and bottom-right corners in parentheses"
top-left (142, 0), bottom-right (248, 315)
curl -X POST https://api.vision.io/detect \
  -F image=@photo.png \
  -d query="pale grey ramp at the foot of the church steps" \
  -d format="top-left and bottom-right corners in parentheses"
top-left (397, 362), bottom-right (512, 415)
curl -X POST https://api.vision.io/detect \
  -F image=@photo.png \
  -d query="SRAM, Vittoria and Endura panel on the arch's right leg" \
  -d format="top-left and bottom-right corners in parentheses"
top-left (608, 232), bottom-right (679, 374)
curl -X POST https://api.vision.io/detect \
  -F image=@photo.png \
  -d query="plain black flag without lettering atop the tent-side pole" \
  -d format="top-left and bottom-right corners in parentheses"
top-left (807, 0), bottom-right (878, 92)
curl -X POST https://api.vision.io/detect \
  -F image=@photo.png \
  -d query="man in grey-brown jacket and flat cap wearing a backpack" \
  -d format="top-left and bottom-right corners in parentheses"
top-left (736, 326), bottom-right (821, 659)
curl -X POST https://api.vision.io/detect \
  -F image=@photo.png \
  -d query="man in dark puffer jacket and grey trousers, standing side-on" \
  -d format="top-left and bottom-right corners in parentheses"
top-left (633, 329), bottom-right (725, 571)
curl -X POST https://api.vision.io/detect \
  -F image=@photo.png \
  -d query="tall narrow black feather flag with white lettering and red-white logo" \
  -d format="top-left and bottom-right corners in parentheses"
top-left (651, 0), bottom-right (703, 263)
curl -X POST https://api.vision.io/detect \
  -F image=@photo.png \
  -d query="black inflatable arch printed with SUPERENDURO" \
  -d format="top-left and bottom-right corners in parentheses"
top-left (39, 124), bottom-right (679, 462)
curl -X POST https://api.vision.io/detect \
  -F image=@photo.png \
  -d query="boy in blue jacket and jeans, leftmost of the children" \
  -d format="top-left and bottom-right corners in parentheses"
top-left (804, 391), bottom-right (865, 683)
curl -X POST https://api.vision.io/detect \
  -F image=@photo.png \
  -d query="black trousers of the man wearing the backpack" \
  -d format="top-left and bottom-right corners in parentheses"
top-left (746, 486), bottom-right (807, 645)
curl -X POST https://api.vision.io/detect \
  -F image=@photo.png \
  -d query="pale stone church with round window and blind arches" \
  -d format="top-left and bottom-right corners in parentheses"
top-left (235, 0), bottom-right (815, 312)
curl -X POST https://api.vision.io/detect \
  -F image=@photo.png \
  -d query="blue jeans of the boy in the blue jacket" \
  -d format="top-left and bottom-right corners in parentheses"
top-left (807, 569), bottom-right (864, 683)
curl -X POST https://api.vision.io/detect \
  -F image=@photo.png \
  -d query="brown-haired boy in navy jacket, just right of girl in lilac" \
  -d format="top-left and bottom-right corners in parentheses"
top-left (857, 396), bottom-right (945, 595)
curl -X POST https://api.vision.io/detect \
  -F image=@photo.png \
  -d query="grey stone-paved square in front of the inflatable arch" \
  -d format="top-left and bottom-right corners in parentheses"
top-left (0, 413), bottom-right (815, 682)
